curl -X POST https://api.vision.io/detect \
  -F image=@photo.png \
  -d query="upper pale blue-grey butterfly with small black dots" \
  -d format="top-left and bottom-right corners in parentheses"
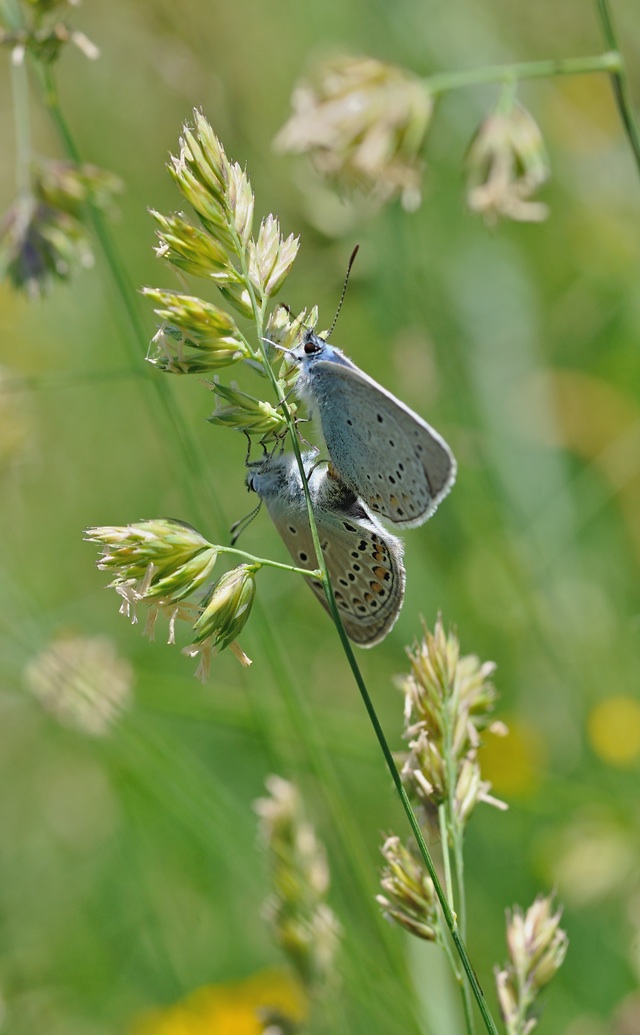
top-left (291, 331), bottom-right (456, 528)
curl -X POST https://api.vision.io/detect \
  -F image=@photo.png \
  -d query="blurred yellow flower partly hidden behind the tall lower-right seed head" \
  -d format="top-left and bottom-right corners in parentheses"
top-left (478, 716), bottom-right (545, 798)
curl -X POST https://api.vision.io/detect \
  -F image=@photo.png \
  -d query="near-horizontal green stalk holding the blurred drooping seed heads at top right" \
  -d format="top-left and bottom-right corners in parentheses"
top-left (423, 50), bottom-right (623, 93)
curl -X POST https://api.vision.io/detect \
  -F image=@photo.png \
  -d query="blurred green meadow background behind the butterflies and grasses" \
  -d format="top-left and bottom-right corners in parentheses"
top-left (0, 0), bottom-right (640, 1035)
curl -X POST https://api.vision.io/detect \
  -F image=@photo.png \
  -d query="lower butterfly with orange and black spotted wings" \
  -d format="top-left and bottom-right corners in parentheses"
top-left (246, 452), bottom-right (405, 647)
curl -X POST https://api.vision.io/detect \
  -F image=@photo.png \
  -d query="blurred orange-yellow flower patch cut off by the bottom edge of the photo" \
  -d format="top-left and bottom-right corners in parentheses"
top-left (130, 970), bottom-right (307, 1035)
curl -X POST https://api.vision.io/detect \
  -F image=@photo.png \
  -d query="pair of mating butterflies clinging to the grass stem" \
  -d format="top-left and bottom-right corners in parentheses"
top-left (248, 331), bottom-right (456, 647)
